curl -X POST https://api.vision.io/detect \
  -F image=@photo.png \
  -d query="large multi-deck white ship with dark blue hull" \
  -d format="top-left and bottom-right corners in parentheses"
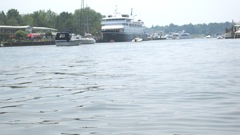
top-left (101, 10), bottom-right (147, 42)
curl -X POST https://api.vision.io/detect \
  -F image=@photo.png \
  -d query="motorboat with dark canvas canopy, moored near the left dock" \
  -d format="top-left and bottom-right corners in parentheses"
top-left (55, 32), bottom-right (81, 46)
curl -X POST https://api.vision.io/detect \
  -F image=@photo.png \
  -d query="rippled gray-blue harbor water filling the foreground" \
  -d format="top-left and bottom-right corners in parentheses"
top-left (0, 39), bottom-right (240, 135)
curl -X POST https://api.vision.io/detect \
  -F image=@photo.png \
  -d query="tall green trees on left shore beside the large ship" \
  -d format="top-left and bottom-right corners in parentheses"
top-left (0, 7), bottom-right (103, 35)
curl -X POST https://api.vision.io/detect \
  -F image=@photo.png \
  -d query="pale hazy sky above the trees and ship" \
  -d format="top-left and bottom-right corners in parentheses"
top-left (0, 0), bottom-right (240, 27)
